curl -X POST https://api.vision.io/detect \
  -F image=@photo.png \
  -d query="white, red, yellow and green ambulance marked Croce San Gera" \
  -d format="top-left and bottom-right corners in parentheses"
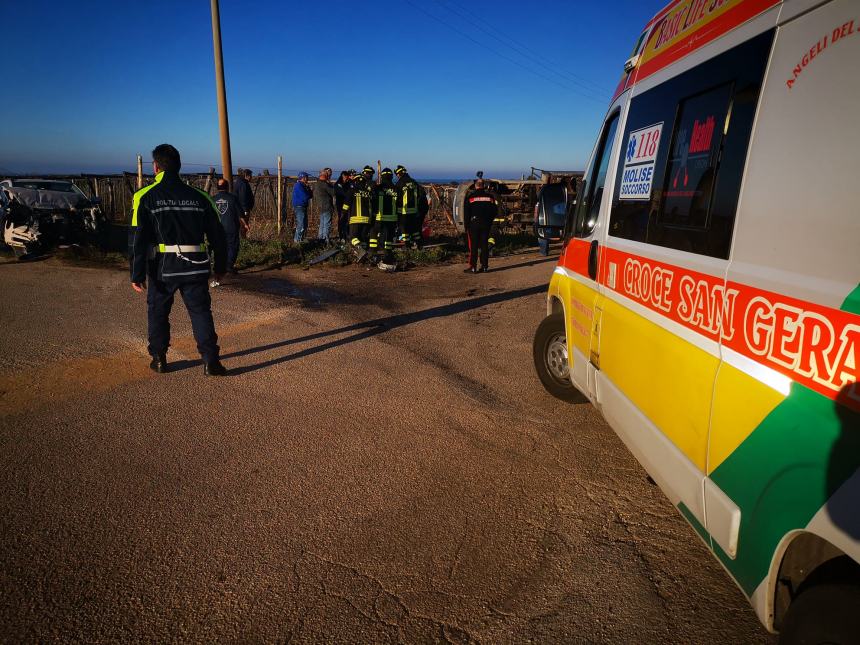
top-left (534, 0), bottom-right (860, 643)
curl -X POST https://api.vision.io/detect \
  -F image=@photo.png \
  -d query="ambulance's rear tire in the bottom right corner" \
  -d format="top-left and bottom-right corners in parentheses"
top-left (779, 584), bottom-right (860, 645)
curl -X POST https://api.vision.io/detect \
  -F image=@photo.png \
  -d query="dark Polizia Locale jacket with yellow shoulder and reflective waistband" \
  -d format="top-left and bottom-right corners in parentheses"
top-left (129, 172), bottom-right (227, 283)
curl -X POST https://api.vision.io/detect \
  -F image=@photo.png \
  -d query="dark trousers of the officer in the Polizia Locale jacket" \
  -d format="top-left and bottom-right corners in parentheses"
top-left (146, 276), bottom-right (219, 363)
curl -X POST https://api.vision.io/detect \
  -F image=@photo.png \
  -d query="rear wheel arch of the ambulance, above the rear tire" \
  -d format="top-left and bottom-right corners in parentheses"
top-left (773, 531), bottom-right (860, 642)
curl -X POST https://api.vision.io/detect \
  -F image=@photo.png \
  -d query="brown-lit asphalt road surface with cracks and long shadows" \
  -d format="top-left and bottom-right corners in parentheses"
top-left (0, 249), bottom-right (773, 643)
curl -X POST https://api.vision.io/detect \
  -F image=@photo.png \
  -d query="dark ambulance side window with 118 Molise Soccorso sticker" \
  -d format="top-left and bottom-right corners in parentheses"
top-left (609, 31), bottom-right (773, 259)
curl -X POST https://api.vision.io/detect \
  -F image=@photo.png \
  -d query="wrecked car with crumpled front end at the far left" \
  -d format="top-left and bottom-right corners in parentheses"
top-left (0, 179), bottom-right (105, 257)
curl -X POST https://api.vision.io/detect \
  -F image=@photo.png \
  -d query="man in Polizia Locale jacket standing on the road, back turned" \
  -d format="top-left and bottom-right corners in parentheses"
top-left (130, 143), bottom-right (227, 376)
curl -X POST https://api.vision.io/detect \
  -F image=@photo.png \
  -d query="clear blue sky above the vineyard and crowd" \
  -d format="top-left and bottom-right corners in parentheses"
top-left (0, 0), bottom-right (663, 178)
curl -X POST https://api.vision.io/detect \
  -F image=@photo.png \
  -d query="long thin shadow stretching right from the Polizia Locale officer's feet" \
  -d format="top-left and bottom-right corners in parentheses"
top-left (218, 284), bottom-right (546, 376)
